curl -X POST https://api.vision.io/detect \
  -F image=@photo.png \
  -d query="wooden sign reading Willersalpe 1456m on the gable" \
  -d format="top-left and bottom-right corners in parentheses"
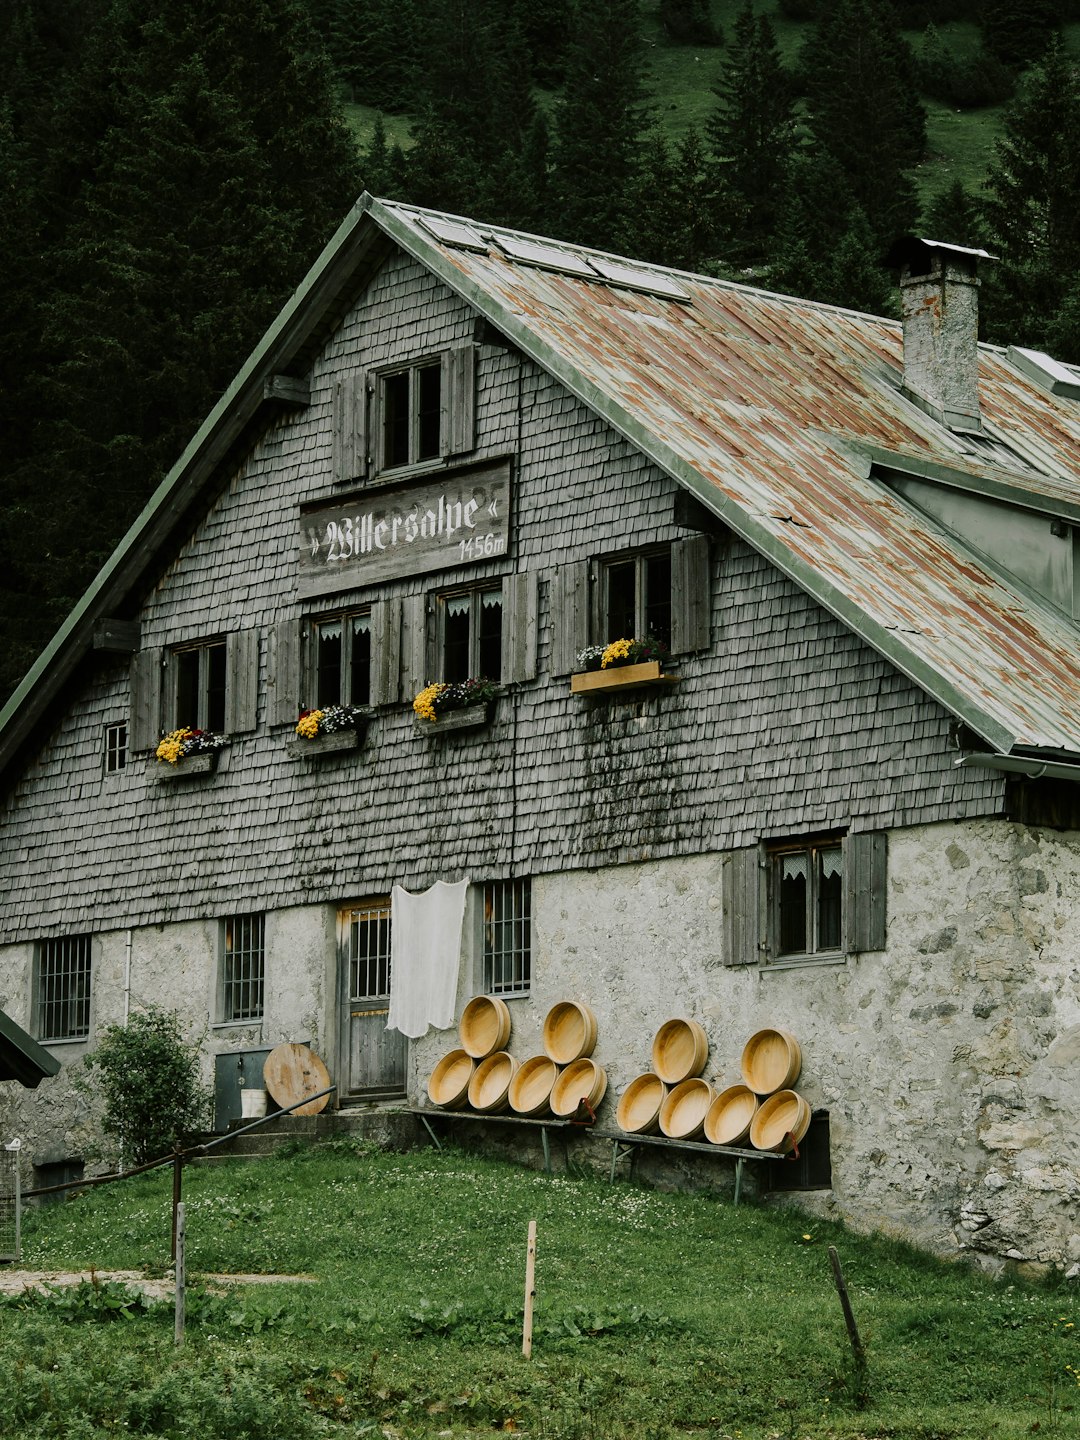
top-left (300, 459), bottom-right (510, 596)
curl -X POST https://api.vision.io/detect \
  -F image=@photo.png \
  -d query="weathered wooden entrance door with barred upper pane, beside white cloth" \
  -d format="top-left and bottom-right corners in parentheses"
top-left (338, 900), bottom-right (408, 1096)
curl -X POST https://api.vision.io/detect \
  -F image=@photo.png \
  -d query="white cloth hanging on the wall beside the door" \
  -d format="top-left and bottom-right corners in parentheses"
top-left (386, 880), bottom-right (468, 1040)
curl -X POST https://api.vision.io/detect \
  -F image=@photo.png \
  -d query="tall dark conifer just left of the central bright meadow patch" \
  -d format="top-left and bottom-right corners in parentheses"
top-left (552, 0), bottom-right (645, 249)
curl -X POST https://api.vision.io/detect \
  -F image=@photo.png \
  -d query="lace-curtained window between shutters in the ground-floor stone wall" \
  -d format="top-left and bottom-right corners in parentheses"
top-left (769, 840), bottom-right (844, 959)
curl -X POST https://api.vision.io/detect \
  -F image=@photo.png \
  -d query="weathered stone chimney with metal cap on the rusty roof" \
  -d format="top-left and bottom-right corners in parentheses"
top-left (888, 236), bottom-right (992, 432)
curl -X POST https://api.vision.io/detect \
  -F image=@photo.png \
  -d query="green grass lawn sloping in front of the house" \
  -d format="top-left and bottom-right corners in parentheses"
top-left (0, 1142), bottom-right (1080, 1440)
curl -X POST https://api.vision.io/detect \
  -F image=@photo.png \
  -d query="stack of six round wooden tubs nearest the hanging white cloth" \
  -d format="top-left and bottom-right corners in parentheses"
top-left (428, 995), bottom-right (608, 1119)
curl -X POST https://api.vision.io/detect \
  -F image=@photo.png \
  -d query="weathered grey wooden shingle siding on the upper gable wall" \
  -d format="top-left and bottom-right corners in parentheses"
top-left (0, 256), bottom-right (1004, 940)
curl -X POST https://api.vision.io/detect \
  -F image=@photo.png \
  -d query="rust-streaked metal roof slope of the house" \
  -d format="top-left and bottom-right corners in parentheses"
top-left (372, 202), bottom-right (1080, 753)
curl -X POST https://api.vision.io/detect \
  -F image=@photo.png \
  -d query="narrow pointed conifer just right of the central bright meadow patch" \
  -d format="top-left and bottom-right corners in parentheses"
top-left (706, 0), bottom-right (795, 264)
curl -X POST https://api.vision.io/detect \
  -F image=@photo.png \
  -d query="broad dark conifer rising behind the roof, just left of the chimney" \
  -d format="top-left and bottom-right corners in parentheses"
top-left (799, 0), bottom-right (926, 249)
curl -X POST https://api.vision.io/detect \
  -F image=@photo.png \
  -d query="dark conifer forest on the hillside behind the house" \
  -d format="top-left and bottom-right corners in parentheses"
top-left (0, 0), bottom-right (1080, 698)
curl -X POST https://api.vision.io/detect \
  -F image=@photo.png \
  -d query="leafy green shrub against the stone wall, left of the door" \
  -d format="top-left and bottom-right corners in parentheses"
top-left (85, 1005), bottom-right (210, 1165)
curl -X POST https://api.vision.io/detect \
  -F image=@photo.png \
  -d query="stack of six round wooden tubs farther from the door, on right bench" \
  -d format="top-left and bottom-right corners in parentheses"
top-left (615, 1020), bottom-right (811, 1153)
